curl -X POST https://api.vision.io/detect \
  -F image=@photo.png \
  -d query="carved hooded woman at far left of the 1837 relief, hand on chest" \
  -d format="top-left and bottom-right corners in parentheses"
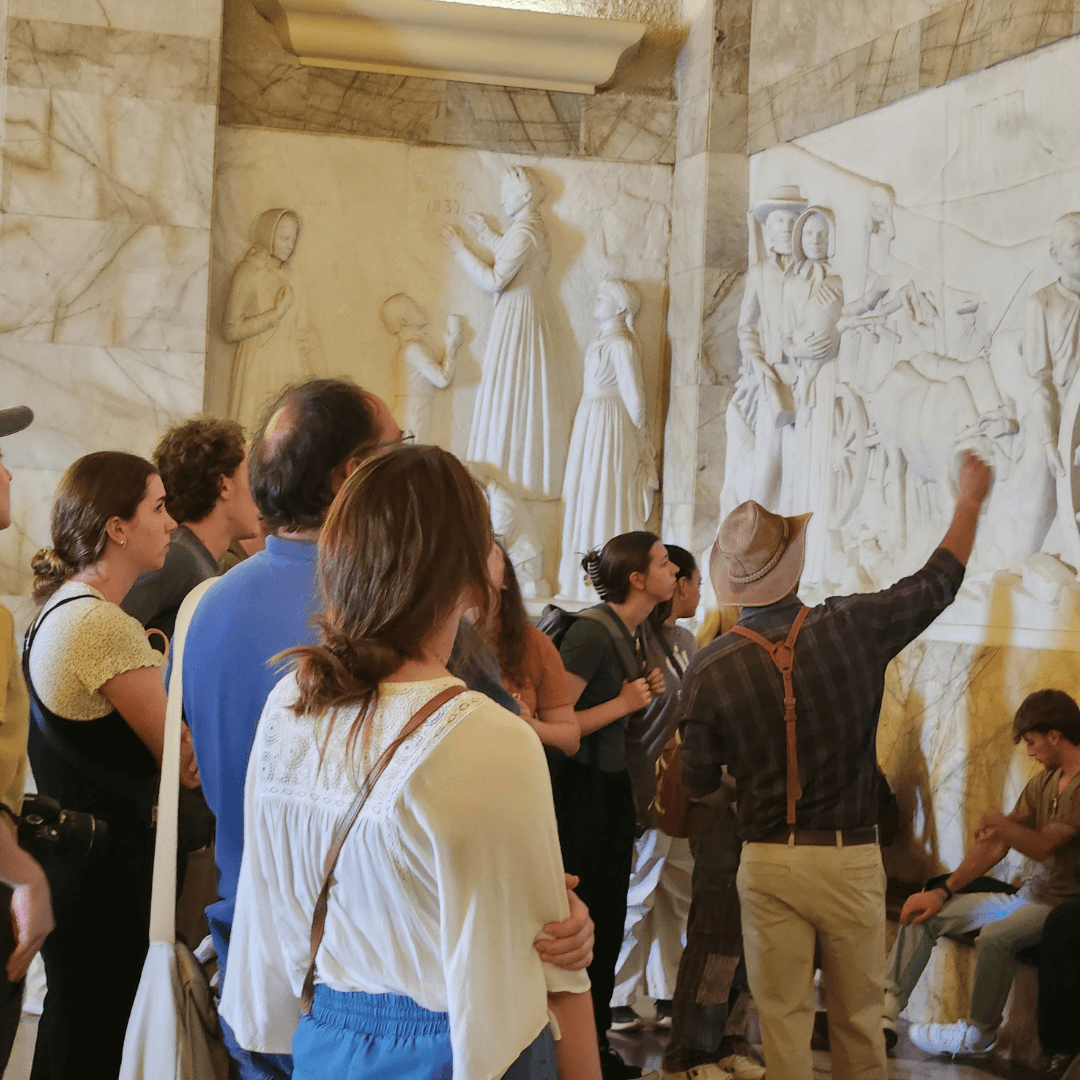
top-left (221, 207), bottom-right (323, 429)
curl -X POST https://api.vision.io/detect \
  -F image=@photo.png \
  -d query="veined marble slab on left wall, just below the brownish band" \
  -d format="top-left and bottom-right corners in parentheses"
top-left (2, 86), bottom-right (215, 229)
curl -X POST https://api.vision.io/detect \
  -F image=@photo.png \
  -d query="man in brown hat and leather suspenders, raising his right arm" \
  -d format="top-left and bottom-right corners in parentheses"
top-left (683, 454), bottom-right (990, 1080)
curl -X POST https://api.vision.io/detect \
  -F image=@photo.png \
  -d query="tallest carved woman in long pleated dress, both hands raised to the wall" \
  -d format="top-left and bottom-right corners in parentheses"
top-left (443, 165), bottom-right (562, 499)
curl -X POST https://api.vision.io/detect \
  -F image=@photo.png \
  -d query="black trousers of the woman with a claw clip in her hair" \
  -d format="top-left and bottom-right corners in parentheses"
top-left (552, 758), bottom-right (636, 1048)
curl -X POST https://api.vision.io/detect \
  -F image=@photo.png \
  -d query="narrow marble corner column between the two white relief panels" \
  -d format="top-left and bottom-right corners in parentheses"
top-left (663, 0), bottom-right (752, 555)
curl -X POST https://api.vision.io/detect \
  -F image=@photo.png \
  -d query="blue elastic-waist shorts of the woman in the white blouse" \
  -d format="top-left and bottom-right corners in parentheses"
top-left (293, 986), bottom-right (556, 1080)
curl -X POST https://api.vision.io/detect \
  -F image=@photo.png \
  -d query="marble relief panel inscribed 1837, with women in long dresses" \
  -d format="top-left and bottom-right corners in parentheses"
top-left (206, 129), bottom-right (672, 596)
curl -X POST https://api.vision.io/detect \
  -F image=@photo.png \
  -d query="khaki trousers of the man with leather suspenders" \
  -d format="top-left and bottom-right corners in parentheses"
top-left (737, 843), bottom-right (888, 1080)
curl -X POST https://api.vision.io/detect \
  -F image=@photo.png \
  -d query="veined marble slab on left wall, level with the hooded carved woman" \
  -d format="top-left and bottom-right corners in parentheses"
top-left (0, 214), bottom-right (208, 352)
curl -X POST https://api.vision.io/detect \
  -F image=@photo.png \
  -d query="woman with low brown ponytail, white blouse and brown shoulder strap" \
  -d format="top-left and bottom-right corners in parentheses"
top-left (221, 446), bottom-right (600, 1080)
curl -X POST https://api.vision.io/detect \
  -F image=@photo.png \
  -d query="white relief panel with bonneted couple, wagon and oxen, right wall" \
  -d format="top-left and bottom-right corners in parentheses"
top-left (721, 42), bottom-right (1080, 647)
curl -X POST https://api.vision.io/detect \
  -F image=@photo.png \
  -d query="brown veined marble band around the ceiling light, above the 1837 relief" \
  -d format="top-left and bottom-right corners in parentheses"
top-left (220, 0), bottom-right (684, 164)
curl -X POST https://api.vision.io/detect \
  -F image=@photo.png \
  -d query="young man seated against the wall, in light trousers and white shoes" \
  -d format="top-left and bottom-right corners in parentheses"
top-left (883, 690), bottom-right (1080, 1054)
